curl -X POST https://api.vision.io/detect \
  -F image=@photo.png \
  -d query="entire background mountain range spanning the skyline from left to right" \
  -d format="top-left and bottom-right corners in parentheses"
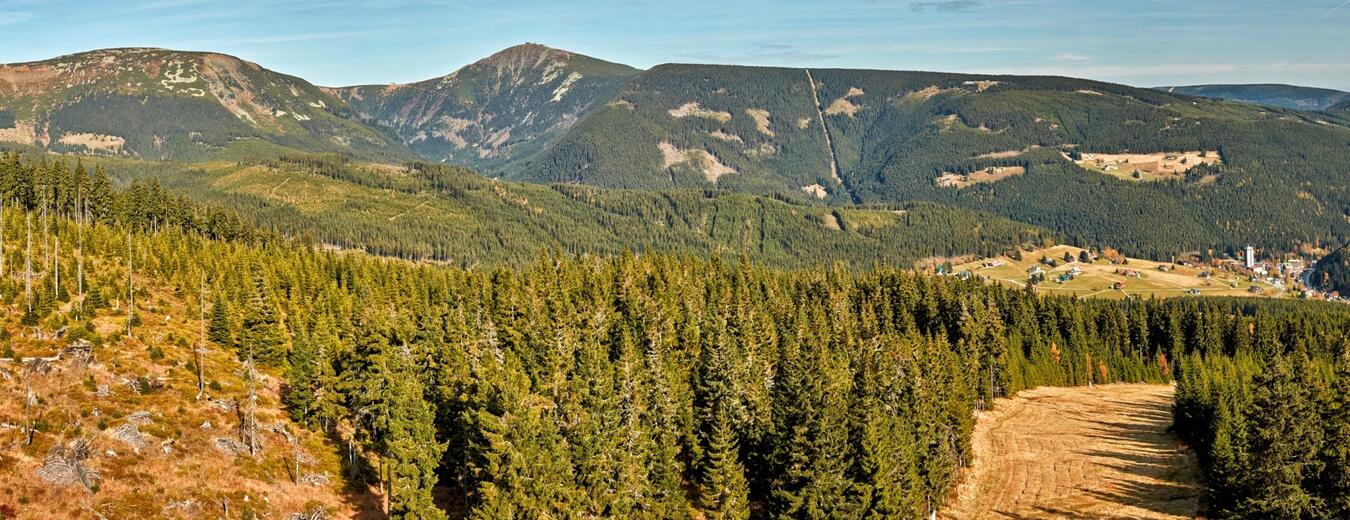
top-left (0, 45), bottom-right (1350, 261)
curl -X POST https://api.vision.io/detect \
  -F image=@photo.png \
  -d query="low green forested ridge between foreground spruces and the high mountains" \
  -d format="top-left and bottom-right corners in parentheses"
top-left (81, 155), bottom-right (1056, 266)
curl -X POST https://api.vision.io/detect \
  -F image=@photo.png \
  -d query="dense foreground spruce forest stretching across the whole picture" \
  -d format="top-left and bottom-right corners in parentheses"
top-left (0, 147), bottom-right (1350, 519)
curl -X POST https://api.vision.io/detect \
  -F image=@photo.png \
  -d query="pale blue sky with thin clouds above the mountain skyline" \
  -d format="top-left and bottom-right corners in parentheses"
top-left (0, 0), bottom-right (1350, 90)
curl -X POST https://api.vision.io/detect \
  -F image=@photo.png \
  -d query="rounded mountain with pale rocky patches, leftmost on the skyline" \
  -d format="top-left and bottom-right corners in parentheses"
top-left (0, 49), bottom-right (412, 159)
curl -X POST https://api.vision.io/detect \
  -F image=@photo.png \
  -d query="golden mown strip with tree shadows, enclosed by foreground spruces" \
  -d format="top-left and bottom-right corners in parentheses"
top-left (942, 385), bottom-right (1199, 519)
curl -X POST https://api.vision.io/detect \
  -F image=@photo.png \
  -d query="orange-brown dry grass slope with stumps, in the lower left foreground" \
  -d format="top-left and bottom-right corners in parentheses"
top-left (0, 253), bottom-right (378, 520)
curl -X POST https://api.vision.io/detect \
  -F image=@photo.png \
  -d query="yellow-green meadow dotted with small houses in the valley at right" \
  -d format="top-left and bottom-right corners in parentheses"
top-left (953, 246), bottom-right (1285, 298)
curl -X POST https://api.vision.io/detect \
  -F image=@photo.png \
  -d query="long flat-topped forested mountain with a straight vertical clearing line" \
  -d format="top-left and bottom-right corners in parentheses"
top-left (513, 65), bottom-right (1350, 257)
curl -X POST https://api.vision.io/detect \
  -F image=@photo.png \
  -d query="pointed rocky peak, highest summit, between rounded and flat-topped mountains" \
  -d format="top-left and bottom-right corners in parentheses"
top-left (329, 43), bottom-right (639, 172)
